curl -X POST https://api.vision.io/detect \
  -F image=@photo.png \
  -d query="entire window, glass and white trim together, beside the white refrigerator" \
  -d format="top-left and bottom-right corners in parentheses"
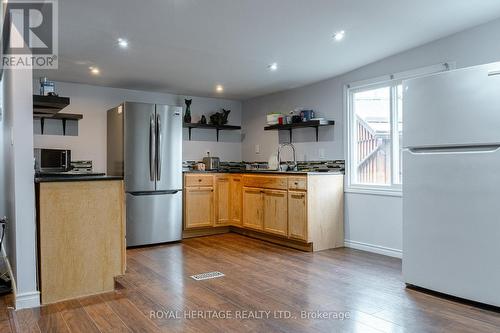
top-left (346, 64), bottom-right (455, 195)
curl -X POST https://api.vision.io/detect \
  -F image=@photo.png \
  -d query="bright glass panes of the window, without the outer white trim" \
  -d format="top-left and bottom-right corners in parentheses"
top-left (349, 81), bottom-right (403, 187)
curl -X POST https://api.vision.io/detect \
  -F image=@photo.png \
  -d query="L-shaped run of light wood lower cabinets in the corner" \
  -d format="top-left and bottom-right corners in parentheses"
top-left (183, 170), bottom-right (344, 251)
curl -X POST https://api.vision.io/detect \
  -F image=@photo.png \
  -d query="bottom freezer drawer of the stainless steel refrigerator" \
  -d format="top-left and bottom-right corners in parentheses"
top-left (126, 191), bottom-right (182, 246)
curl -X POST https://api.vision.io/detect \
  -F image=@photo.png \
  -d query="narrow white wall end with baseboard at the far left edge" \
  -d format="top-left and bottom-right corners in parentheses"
top-left (2, 70), bottom-right (40, 308)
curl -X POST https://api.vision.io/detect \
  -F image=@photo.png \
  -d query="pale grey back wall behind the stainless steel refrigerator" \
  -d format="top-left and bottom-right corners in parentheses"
top-left (33, 79), bottom-right (241, 172)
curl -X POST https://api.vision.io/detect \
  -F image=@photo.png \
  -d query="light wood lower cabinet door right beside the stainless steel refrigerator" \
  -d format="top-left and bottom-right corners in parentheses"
top-left (184, 186), bottom-right (214, 229)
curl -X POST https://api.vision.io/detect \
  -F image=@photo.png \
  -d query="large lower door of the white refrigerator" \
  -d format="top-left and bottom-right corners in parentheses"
top-left (403, 147), bottom-right (500, 306)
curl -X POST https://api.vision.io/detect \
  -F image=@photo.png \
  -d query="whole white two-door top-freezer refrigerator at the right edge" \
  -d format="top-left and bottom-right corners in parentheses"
top-left (403, 63), bottom-right (500, 306)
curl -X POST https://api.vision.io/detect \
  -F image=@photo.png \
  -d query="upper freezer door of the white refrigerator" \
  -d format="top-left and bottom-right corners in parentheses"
top-left (403, 63), bottom-right (500, 147)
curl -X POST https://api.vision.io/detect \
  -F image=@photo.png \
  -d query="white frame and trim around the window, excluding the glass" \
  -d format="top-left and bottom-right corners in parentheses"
top-left (344, 62), bottom-right (456, 197)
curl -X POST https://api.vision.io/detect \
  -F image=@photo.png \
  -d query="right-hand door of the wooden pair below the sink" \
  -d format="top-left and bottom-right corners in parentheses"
top-left (264, 190), bottom-right (288, 236)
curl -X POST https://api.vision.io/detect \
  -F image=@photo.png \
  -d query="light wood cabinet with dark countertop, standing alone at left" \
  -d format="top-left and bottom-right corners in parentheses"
top-left (35, 176), bottom-right (126, 304)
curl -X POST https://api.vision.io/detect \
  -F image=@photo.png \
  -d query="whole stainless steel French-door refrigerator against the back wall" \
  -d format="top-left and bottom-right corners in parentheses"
top-left (107, 102), bottom-right (182, 246)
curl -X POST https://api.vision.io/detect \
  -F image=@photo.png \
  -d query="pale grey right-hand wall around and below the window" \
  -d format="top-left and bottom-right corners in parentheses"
top-left (242, 20), bottom-right (500, 256)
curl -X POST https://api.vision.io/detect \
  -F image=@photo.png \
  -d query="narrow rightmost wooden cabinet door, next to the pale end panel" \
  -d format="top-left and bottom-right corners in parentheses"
top-left (288, 191), bottom-right (307, 241)
